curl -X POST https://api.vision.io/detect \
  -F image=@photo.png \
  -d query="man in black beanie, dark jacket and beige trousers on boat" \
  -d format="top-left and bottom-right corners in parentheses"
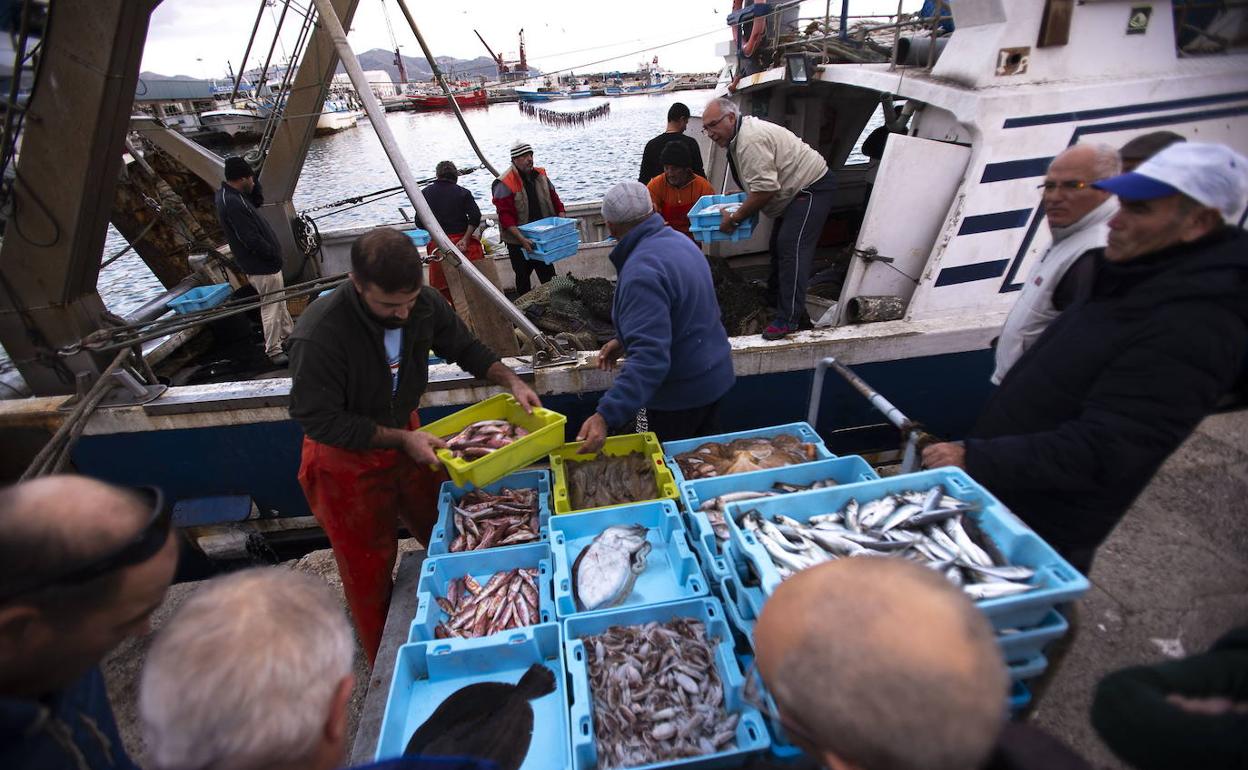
top-left (216, 156), bottom-right (295, 367)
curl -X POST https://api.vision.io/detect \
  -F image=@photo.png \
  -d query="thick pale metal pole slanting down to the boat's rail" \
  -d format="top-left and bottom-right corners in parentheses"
top-left (314, 0), bottom-right (570, 363)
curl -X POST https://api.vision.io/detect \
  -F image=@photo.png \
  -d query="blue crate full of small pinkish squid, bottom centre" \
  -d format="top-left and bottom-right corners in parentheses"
top-left (563, 598), bottom-right (770, 770)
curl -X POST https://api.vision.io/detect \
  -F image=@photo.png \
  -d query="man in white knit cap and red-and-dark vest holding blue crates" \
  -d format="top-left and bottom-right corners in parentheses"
top-left (493, 141), bottom-right (564, 295)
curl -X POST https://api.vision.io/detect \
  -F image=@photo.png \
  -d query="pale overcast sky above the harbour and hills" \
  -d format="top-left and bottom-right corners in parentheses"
top-left (142, 0), bottom-right (922, 77)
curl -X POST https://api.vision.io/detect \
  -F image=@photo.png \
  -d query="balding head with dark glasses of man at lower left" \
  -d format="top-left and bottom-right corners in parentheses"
top-left (0, 475), bottom-right (177, 695)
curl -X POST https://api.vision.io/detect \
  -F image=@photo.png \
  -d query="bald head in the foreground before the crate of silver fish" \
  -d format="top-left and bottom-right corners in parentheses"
top-left (754, 558), bottom-right (1008, 770)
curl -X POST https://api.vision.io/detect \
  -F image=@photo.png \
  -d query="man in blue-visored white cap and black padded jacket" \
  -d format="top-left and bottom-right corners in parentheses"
top-left (924, 142), bottom-right (1248, 572)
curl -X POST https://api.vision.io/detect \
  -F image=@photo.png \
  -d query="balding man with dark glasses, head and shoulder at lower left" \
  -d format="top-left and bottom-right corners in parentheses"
top-left (0, 475), bottom-right (177, 770)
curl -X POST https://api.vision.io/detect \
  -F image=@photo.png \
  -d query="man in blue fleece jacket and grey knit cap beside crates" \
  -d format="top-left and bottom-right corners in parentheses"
top-left (577, 182), bottom-right (736, 452)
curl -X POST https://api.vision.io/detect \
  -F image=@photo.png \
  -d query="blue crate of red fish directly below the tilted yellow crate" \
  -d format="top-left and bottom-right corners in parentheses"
top-left (428, 470), bottom-right (550, 557)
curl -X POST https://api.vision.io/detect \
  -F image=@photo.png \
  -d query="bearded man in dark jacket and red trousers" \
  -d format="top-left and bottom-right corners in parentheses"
top-left (291, 227), bottom-right (542, 664)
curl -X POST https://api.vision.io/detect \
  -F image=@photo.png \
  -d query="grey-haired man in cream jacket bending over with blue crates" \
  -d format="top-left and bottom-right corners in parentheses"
top-left (703, 97), bottom-right (836, 339)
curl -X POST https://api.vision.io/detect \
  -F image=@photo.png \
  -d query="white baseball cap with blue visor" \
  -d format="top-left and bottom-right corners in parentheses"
top-left (1092, 142), bottom-right (1248, 222)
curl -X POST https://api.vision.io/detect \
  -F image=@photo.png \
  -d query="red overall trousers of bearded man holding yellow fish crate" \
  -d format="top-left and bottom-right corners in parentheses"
top-left (300, 412), bottom-right (447, 666)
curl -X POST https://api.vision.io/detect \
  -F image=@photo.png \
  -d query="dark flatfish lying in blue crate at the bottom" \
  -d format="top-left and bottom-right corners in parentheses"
top-left (403, 663), bottom-right (555, 770)
